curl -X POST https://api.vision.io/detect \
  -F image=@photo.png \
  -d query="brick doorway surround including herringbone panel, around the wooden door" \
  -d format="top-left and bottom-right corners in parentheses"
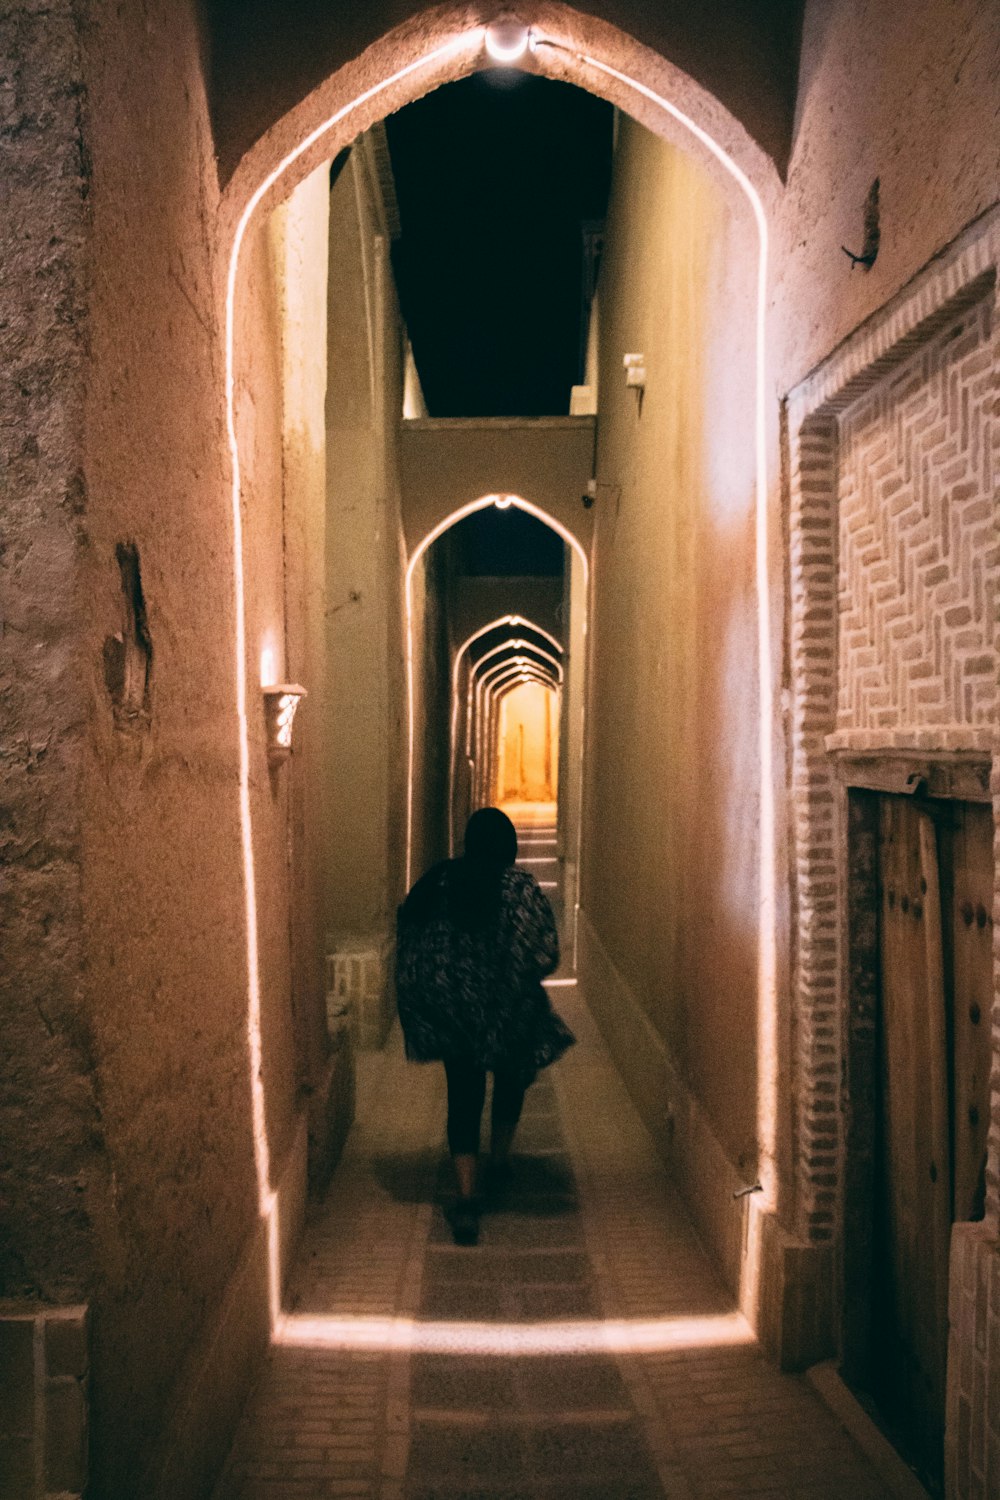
top-left (789, 213), bottom-right (1000, 1266)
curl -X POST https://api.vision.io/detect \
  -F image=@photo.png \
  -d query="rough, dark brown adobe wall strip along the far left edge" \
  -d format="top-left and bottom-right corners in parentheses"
top-left (0, 5), bottom-right (108, 1301)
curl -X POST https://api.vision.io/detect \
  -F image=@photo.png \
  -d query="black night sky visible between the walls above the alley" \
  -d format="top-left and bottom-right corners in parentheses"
top-left (385, 69), bottom-right (612, 417)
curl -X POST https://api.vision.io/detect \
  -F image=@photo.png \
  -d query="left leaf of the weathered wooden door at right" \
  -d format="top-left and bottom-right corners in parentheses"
top-left (873, 797), bottom-right (952, 1475)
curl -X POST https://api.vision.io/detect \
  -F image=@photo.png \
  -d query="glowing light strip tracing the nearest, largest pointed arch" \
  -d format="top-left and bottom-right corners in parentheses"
top-left (225, 14), bottom-right (778, 1328)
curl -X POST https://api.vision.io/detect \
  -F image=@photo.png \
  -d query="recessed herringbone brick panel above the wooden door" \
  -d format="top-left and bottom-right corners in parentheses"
top-left (837, 302), bottom-right (1000, 731)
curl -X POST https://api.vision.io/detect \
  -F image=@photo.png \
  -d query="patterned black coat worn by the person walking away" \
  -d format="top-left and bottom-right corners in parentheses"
top-left (396, 860), bottom-right (574, 1082)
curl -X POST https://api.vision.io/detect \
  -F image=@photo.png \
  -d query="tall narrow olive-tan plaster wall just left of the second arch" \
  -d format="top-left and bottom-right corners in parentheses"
top-left (324, 141), bottom-right (406, 947)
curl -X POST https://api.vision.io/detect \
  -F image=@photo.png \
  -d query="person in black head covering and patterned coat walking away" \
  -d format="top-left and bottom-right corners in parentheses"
top-left (396, 807), bottom-right (574, 1245)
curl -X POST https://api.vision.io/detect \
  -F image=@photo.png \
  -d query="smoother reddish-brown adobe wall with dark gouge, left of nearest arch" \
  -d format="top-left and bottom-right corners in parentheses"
top-left (81, 3), bottom-right (277, 1496)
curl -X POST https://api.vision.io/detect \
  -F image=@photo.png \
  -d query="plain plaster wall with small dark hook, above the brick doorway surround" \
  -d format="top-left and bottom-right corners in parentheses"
top-left (771, 0), bottom-right (1000, 396)
